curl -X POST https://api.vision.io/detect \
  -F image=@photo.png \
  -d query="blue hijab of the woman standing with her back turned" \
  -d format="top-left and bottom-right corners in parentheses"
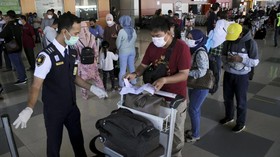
top-left (119, 15), bottom-right (134, 41)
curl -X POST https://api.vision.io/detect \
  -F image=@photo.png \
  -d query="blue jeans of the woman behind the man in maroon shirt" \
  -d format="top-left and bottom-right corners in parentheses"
top-left (188, 89), bottom-right (209, 137)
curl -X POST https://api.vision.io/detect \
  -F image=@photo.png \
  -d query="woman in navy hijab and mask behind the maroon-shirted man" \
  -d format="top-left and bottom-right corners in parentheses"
top-left (185, 29), bottom-right (209, 142)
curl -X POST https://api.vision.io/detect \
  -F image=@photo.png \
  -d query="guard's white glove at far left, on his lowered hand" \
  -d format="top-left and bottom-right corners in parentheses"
top-left (13, 107), bottom-right (33, 129)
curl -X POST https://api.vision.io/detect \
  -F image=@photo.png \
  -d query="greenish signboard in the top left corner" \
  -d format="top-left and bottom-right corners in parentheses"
top-left (0, 0), bottom-right (21, 15)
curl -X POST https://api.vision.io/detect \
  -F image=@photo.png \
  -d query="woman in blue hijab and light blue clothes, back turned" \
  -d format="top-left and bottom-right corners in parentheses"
top-left (116, 15), bottom-right (137, 87)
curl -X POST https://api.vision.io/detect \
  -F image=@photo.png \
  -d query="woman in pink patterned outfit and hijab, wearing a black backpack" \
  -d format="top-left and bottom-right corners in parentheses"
top-left (75, 22), bottom-right (104, 100)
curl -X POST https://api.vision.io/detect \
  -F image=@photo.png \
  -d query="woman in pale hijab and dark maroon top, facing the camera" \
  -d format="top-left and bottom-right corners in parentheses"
top-left (103, 14), bottom-right (120, 84)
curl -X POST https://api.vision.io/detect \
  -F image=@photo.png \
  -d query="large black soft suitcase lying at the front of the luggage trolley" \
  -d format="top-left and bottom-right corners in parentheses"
top-left (96, 109), bottom-right (160, 157)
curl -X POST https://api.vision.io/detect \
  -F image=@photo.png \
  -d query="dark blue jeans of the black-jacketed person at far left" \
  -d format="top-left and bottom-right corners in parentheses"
top-left (8, 52), bottom-right (26, 81)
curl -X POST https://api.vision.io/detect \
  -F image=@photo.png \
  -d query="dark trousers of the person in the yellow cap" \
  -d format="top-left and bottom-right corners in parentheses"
top-left (223, 72), bottom-right (249, 125)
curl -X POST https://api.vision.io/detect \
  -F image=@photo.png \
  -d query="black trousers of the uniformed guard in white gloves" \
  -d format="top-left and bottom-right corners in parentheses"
top-left (44, 104), bottom-right (87, 157)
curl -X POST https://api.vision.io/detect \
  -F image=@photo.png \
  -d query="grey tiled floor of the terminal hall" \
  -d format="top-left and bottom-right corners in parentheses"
top-left (0, 27), bottom-right (280, 157)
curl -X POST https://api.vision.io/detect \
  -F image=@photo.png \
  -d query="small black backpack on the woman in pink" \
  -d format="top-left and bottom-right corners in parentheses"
top-left (79, 36), bottom-right (95, 64)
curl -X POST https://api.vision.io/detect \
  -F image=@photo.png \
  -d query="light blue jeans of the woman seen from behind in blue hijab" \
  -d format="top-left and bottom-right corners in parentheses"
top-left (119, 50), bottom-right (136, 87)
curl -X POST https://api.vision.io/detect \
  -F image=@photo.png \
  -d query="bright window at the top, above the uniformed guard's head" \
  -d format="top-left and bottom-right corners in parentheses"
top-left (76, 0), bottom-right (98, 20)
